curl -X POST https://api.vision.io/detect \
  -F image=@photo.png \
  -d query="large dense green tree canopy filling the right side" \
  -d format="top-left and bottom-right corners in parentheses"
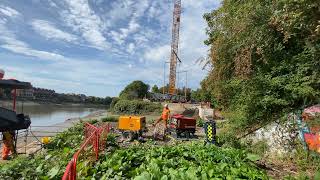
top-left (202, 0), bottom-right (320, 130)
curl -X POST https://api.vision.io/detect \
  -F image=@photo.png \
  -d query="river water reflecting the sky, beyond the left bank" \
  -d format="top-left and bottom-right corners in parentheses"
top-left (2, 103), bottom-right (99, 126)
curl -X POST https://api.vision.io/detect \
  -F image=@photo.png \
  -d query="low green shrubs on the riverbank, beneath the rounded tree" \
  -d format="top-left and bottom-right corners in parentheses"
top-left (113, 100), bottom-right (161, 114)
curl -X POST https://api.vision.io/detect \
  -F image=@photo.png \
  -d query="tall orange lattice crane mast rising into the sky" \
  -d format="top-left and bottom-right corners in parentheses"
top-left (169, 0), bottom-right (181, 95)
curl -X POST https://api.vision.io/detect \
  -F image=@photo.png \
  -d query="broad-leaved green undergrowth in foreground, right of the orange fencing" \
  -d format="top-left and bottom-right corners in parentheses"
top-left (91, 143), bottom-right (267, 180)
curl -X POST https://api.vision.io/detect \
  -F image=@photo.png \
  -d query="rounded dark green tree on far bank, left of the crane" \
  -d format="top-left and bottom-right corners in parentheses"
top-left (119, 81), bottom-right (149, 100)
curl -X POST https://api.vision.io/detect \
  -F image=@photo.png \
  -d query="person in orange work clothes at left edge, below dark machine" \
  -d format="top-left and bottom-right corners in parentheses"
top-left (2, 131), bottom-right (15, 160)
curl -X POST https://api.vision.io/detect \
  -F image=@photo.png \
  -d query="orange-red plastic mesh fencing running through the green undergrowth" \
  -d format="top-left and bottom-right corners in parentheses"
top-left (62, 123), bottom-right (110, 180)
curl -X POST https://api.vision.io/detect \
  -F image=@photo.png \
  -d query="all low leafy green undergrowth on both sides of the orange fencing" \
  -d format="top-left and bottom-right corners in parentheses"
top-left (0, 121), bottom-right (267, 180)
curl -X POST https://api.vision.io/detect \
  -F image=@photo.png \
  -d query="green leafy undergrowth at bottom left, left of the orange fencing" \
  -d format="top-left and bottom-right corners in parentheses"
top-left (0, 123), bottom-right (84, 180)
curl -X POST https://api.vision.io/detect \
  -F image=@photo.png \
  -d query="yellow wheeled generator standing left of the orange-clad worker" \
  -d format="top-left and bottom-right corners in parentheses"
top-left (118, 116), bottom-right (147, 140)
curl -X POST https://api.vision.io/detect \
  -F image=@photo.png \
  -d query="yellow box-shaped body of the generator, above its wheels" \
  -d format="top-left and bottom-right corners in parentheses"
top-left (118, 116), bottom-right (146, 131)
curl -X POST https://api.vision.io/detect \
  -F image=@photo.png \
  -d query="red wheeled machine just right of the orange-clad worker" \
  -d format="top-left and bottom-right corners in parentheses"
top-left (169, 114), bottom-right (197, 139)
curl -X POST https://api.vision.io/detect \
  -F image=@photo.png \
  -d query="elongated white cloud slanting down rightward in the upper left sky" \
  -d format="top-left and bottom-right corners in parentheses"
top-left (31, 19), bottom-right (77, 42)
